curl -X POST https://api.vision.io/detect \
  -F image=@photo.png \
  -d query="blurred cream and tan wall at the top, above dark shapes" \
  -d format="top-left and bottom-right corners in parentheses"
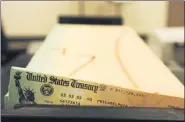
top-left (1, 1), bottom-right (184, 37)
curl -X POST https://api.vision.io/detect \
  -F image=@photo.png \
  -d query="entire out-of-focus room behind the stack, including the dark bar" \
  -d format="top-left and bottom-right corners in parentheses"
top-left (1, 1), bottom-right (184, 107)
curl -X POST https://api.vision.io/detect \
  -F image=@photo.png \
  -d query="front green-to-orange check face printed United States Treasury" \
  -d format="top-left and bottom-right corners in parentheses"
top-left (8, 67), bottom-right (184, 109)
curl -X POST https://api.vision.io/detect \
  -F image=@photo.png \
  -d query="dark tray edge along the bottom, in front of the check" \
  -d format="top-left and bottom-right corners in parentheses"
top-left (2, 105), bottom-right (184, 122)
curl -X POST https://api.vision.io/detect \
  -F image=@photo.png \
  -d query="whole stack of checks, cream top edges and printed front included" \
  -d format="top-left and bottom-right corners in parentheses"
top-left (6, 25), bottom-right (184, 109)
